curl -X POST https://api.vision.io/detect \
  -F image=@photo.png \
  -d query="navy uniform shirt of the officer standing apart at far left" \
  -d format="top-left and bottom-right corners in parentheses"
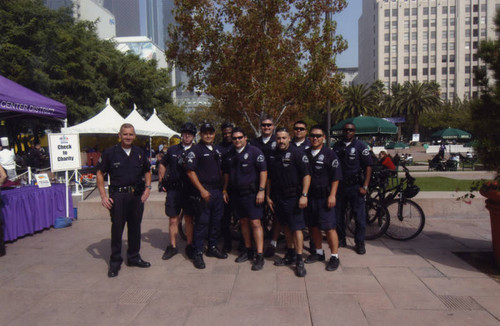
top-left (97, 144), bottom-right (150, 187)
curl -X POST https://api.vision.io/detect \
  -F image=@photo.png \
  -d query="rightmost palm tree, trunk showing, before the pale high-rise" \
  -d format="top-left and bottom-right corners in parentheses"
top-left (390, 81), bottom-right (441, 134)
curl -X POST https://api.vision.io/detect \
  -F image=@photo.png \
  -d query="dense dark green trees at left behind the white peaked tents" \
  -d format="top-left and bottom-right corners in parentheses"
top-left (0, 0), bottom-right (185, 132)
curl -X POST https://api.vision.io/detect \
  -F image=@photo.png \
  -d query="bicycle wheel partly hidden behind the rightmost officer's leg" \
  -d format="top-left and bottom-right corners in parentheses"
top-left (346, 199), bottom-right (390, 240)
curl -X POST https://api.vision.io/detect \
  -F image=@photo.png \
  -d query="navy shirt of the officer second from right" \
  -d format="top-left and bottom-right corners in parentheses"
top-left (306, 145), bottom-right (342, 187)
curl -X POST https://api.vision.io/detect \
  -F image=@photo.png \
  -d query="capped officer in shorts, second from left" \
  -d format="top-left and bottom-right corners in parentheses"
top-left (158, 122), bottom-right (196, 260)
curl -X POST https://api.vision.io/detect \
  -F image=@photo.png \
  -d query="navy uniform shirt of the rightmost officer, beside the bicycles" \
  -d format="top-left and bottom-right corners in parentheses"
top-left (333, 139), bottom-right (372, 179)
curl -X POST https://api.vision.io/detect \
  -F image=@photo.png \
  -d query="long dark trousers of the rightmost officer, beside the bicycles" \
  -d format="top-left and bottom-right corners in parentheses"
top-left (335, 185), bottom-right (366, 243)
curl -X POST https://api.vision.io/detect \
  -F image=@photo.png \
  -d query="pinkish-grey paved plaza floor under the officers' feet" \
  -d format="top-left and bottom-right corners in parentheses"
top-left (0, 217), bottom-right (500, 326)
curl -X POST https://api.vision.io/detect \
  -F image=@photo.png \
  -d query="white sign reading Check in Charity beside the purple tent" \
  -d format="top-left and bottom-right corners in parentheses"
top-left (49, 134), bottom-right (82, 172)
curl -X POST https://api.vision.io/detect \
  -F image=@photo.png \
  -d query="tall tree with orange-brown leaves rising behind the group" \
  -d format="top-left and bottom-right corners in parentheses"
top-left (166, 0), bottom-right (346, 134)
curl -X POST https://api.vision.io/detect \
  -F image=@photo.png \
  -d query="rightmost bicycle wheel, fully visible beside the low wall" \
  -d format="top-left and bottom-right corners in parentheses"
top-left (385, 199), bottom-right (425, 241)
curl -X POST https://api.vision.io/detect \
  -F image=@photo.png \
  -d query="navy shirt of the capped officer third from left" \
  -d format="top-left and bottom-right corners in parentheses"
top-left (186, 143), bottom-right (222, 186)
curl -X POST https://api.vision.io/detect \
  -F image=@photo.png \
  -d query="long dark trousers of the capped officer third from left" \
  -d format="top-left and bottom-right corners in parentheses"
top-left (193, 189), bottom-right (224, 253)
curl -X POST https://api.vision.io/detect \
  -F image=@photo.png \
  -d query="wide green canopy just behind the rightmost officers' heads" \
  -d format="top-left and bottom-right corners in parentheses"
top-left (330, 115), bottom-right (398, 136)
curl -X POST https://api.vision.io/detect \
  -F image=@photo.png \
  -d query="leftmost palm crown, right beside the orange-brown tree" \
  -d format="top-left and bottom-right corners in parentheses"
top-left (333, 84), bottom-right (378, 120)
